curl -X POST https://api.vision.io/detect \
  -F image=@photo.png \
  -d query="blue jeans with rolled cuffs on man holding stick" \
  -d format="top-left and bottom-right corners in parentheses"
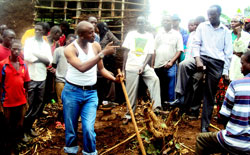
top-left (62, 83), bottom-right (98, 155)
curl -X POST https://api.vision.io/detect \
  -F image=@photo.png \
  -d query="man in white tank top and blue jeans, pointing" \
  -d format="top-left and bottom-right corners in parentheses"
top-left (62, 21), bottom-right (120, 155)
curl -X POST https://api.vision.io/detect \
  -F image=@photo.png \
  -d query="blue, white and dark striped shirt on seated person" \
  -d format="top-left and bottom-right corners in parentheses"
top-left (217, 73), bottom-right (250, 154)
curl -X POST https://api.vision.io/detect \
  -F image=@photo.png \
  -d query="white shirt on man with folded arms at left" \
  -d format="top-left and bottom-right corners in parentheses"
top-left (24, 37), bottom-right (53, 81)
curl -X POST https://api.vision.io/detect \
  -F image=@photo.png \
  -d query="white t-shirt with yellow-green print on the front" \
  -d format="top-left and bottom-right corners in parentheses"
top-left (122, 31), bottom-right (154, 71)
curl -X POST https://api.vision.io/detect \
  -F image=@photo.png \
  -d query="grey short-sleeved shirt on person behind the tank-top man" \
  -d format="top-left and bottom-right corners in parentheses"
top-left (53, 46), bottom-right (68, 82)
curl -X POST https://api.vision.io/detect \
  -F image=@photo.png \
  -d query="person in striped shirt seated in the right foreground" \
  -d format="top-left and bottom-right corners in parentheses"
top-left (196, 51), bottom-right (250, 155)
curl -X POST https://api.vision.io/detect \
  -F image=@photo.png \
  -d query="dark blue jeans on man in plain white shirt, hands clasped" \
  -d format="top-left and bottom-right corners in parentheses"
top-left (155, 64), bottom-right (177, 103)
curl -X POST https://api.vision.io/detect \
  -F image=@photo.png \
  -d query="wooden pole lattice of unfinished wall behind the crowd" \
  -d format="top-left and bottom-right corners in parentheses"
top-left (35, 0), bottom-right (148, 40)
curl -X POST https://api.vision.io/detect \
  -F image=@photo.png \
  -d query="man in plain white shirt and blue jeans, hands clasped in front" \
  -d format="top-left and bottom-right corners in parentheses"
top-left (154, 16), bottom-right (183, 106)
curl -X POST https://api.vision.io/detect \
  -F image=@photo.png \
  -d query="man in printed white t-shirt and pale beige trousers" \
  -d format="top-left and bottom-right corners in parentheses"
top-left (122, 17), bottom-right (161, 124)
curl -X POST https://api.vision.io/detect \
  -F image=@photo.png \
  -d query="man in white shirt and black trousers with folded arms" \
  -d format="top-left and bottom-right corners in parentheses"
top-left (24, 22), bottom-right (53, 140)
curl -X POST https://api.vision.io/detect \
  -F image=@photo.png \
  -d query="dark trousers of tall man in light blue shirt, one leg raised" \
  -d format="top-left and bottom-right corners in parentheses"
top-left (175, 56), bottom-right (224, 128)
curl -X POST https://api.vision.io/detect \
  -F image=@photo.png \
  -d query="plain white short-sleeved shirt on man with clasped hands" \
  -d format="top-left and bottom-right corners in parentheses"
top-left (154, 29), bottom-right (183, 68)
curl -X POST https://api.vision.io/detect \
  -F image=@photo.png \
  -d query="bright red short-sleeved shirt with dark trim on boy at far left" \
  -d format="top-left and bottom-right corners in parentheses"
top-left (0, 57), bottom-right (30, 107)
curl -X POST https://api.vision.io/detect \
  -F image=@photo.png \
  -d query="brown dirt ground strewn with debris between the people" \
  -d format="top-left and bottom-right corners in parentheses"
top-left (21, 100), bottom-right (222, 155)
